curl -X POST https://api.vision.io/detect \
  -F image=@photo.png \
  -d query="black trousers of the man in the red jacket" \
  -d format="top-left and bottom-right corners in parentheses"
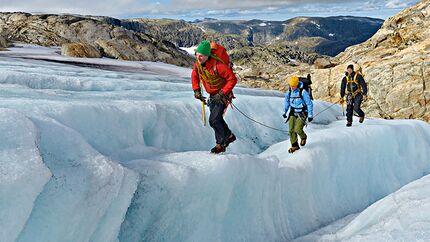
top-left (209, 100), bottom-right (231, 144)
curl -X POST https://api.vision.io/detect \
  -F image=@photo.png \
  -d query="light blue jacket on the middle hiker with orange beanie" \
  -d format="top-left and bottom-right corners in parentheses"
top-left (284, 88), bottom-right (314, 118)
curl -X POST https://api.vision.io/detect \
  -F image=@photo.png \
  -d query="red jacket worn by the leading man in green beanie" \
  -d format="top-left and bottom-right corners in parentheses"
top-left (191, 58), bottom-right (237, 95)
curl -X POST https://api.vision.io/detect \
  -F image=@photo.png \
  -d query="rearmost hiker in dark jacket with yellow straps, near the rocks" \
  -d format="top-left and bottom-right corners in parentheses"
top-left (340, 65), bottom-right (367, 127)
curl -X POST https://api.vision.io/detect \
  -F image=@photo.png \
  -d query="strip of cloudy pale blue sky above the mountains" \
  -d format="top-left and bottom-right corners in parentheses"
top-left (0, 0), bottom-right (418, 20)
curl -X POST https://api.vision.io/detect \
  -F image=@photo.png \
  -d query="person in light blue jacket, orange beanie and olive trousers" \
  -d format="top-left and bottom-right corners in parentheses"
top-left (282, 76), bottom-right (313, 153)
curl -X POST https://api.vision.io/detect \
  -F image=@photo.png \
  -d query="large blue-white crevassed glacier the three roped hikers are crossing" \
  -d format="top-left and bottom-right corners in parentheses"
top-left (0, 46), bottom-right (430, 241)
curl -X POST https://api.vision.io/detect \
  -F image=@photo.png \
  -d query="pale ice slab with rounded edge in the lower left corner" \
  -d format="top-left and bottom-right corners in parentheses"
top-left (0, 108), bottom-right (51, 241)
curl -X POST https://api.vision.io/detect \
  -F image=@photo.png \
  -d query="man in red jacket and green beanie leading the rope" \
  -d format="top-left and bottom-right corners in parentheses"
top-left (191, 41), bottom-right (237, 154)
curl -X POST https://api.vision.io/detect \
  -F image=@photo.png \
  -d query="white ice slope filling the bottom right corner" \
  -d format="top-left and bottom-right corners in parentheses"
top-left (294, 175), bottom-right (430, 242)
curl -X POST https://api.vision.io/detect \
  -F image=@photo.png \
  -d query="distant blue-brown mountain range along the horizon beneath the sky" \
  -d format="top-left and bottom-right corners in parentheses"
top-left (105, 16), bottom-right (383, 56)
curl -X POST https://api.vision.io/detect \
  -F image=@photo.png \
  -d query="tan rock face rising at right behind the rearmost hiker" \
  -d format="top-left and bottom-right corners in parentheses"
top-left (306, 0), bottom-right (430, 122)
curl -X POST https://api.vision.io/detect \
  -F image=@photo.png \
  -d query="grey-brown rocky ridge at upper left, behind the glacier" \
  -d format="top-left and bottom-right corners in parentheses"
top-left (0, 13), bottom-right (194, 66)
